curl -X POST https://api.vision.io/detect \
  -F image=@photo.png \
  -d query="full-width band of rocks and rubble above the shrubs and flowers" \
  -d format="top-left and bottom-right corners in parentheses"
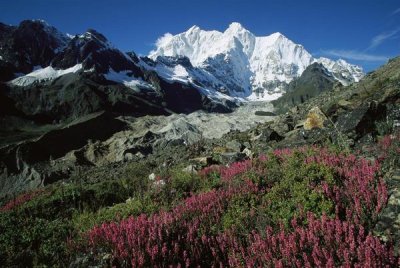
top-left (1, 54), bottom-right (400, 198)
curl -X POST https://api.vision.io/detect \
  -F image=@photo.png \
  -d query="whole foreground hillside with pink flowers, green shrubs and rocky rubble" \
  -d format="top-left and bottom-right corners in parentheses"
top-left (0, 50), bottom-right (400, 267)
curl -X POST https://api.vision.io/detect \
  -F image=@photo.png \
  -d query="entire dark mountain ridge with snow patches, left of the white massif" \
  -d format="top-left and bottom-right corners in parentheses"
top-left (0, 21), bottom-right (236, 120)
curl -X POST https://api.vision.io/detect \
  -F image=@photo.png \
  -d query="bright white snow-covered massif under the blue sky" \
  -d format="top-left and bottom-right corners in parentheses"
top-left (149, 22), bottom-right (364, 99)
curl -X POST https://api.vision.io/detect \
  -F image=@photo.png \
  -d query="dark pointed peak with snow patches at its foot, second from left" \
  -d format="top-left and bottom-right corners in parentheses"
top-left (11, 29), bottom-right (149, 89)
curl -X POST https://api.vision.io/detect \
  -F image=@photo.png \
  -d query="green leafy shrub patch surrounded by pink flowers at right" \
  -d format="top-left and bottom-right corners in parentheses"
top-left (263, 153), bottom-right (335, 229)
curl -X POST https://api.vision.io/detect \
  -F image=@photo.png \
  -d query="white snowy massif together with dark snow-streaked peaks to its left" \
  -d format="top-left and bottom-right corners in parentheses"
top-left (0, 20), bottom-right (363, 111)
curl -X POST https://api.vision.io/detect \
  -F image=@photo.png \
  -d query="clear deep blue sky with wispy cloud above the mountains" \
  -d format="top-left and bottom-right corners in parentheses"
top-left (0, 0), bottom-right (400, 71)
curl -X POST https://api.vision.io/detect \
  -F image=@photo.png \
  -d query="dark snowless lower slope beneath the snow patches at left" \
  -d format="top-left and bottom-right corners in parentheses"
top-left (0, 71), bottom-right (173, 123)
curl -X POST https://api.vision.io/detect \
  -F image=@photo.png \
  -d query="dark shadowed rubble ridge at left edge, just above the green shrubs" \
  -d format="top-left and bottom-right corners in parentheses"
top-left (0, 112), bottom-right (126, 196)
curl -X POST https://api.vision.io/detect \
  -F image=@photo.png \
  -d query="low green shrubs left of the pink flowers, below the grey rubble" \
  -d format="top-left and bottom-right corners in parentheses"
top-left (0, 163), bottom-right (223, 266)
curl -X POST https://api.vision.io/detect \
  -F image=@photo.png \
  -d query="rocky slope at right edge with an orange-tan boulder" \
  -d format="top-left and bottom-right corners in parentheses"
top-left (262, 55), bottom-right (400, 148)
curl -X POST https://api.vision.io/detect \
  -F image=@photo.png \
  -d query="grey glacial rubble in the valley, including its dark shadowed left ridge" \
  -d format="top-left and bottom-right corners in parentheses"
top-left (0, 103), bottom-right (274, 195)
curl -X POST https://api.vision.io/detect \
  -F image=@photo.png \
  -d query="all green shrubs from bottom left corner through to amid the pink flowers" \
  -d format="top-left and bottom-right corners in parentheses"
top-left (0, 138), bottom-right (398, 266)
